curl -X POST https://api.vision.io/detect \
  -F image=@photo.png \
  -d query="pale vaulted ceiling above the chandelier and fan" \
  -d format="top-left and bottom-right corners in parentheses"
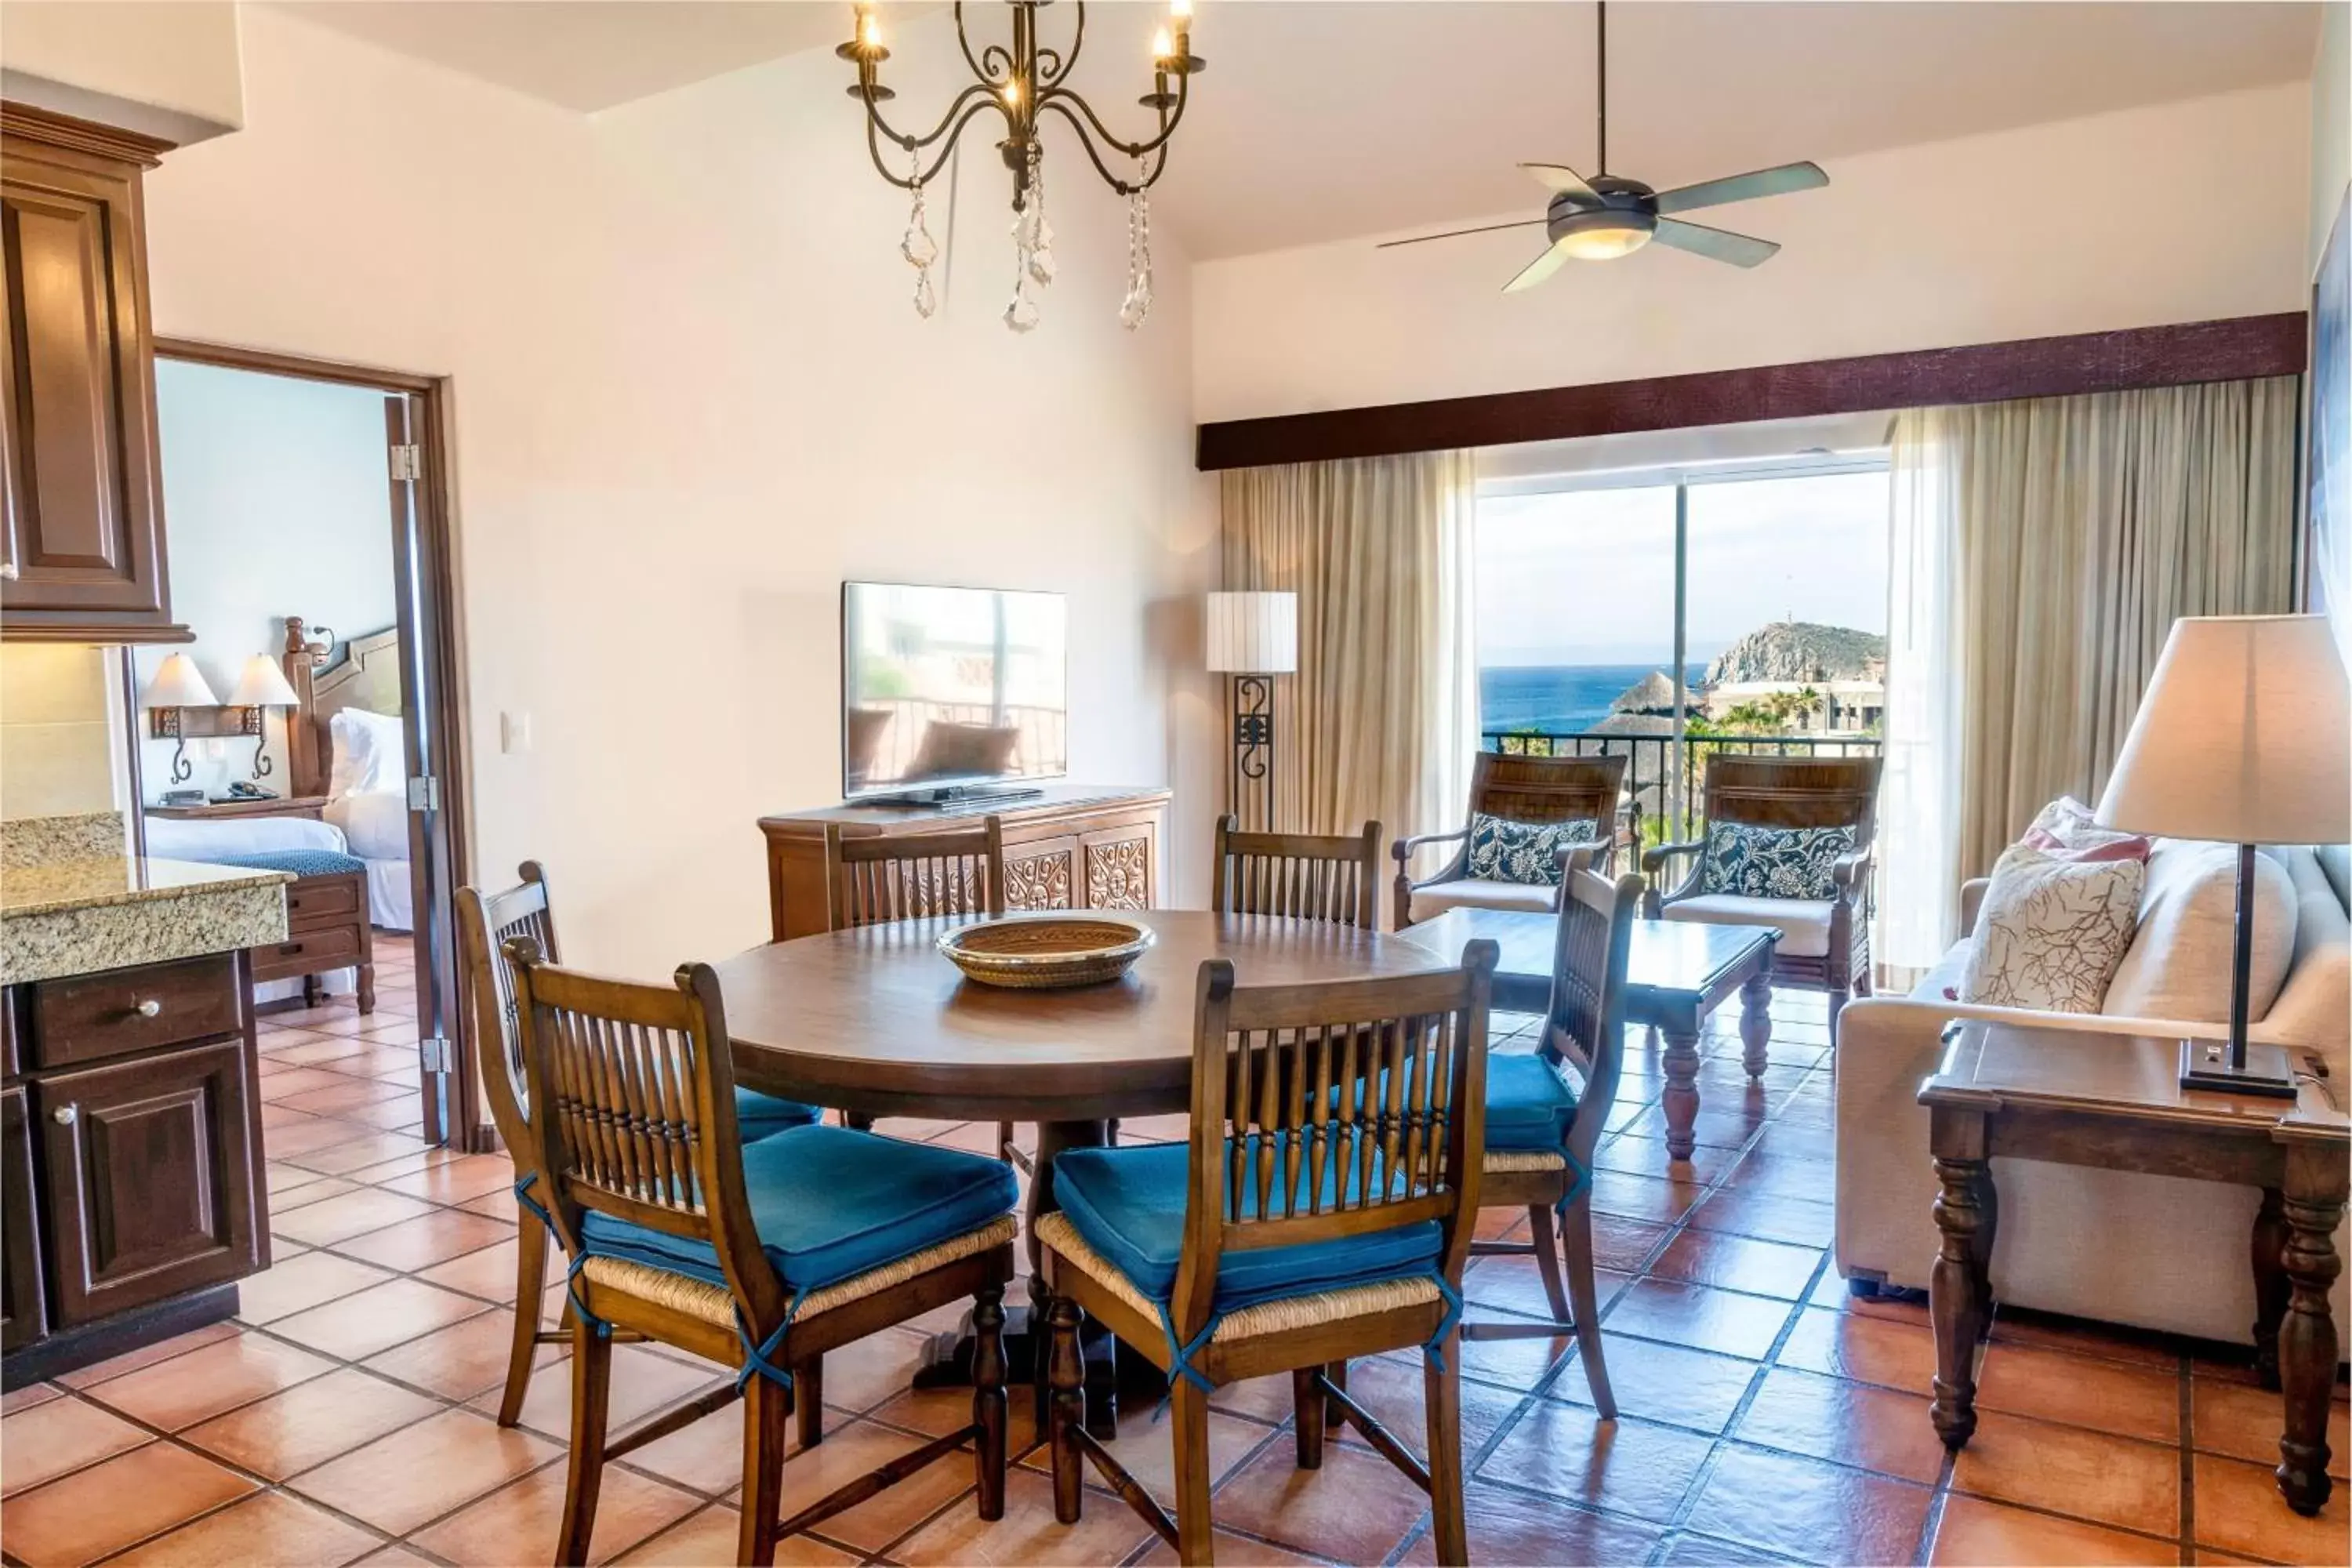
top-left (285, 0), bottom-right (2319, 259)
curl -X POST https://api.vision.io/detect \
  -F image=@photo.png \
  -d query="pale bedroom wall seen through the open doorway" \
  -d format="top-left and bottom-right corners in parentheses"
top-left (132, 360), bottom-right (397, 804)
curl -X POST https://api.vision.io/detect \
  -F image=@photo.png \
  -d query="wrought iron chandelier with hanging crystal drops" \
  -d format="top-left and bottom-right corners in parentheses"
top-left (835, 0), bottom-right (1207, 332)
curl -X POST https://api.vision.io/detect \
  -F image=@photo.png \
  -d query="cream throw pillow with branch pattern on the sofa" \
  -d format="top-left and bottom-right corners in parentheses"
top-left (1959, 844), bottom-right (2147, 1013)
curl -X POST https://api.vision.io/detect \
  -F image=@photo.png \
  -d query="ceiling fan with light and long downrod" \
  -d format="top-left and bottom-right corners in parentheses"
top-left (1381, 0), bottom-right (1830, 294)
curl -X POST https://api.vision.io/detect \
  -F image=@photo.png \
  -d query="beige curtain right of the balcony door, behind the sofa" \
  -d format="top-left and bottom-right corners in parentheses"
top-left (1882, 376), bottom-right (2300, 961)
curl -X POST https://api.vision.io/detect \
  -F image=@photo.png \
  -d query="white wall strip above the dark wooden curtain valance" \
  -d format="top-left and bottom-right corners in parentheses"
top-left (1192, 85), bottom-right (2312, 421)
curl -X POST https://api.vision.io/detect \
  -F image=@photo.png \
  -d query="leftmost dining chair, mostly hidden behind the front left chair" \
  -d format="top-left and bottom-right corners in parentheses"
top-left (456, 860), bottom-right (816, 1427)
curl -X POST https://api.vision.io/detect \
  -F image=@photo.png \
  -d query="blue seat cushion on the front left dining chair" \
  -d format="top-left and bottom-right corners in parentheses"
top-left (581, 1126), bottom-right (1018, 1290)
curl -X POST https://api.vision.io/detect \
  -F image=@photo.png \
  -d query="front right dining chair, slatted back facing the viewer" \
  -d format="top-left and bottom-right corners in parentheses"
top-left (1035, 940), bottom-right (1496, 1563)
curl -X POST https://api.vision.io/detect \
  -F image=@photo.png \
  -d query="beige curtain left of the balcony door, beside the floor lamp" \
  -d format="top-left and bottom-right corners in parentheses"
top-left (1223, 452), bottom-right (1477, 860)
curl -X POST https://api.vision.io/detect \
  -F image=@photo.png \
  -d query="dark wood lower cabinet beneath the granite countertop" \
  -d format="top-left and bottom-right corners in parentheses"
top-left (0, 952), bottom-right (268, 1387)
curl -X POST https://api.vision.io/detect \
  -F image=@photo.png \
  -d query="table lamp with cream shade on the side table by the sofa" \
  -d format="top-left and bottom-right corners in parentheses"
top-left (2096, 616), bottom-right (2352, 1098)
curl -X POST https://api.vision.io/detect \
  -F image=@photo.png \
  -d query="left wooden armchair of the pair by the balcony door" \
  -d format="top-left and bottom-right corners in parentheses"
top-left (1390, 753), bottom-right (1642, 931)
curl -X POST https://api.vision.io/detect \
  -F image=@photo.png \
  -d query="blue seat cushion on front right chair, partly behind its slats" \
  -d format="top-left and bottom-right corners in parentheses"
top-left (1054, 1142), bottom-right (1444, 1312)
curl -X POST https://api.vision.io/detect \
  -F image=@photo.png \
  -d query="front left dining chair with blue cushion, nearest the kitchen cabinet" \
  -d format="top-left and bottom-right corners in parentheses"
top-left (506, 938), bottom-right (1018, 1563)
